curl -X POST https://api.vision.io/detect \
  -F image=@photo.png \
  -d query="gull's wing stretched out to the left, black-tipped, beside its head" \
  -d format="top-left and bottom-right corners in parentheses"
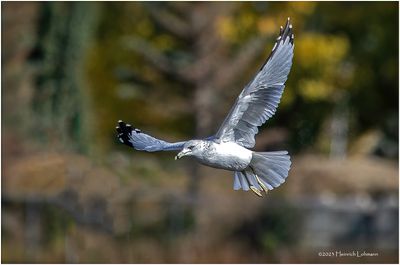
top-left (116, 120), bottom-right (186, 152)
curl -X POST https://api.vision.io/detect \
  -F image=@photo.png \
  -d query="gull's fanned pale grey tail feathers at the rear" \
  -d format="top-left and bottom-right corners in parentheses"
top-left (233, 151), bottom-right (291, 196)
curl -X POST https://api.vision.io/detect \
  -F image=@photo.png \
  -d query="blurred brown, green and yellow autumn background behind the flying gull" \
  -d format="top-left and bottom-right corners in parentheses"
top-left (1, 2), bottom-right (399, 263)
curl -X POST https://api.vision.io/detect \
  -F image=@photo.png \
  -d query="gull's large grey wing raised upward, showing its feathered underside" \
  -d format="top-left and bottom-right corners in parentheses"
top-left (216, 18), bottom-right (294, 148)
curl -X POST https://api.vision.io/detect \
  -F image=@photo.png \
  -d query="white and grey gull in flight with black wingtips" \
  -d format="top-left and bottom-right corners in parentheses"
top-left (116, 18), bottom-right (294, 197)
